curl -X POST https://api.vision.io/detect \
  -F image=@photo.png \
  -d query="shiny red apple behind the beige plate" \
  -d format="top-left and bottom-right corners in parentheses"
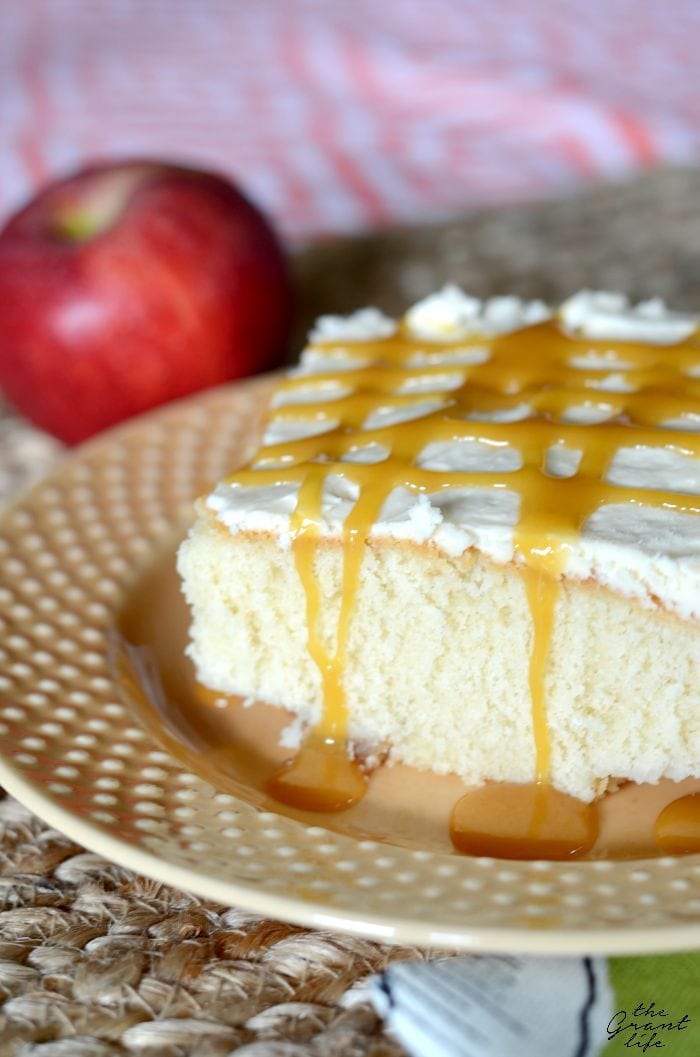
top-left (0, 161), bottom-right (292, 444)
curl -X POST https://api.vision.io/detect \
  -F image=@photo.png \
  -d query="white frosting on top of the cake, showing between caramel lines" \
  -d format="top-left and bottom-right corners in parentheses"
top-left (206, 286), bottom-right (700, 618)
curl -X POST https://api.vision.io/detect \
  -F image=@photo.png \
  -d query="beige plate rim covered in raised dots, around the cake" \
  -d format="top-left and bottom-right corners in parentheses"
top-left (0, 379), bottom-right (700, 953)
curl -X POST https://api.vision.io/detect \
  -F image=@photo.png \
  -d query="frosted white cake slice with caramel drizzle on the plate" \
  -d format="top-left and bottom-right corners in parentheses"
top-left (179, 286), bottom-right (700, 800)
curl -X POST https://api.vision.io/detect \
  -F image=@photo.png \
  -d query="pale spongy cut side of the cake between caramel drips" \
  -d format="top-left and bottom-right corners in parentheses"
top-left (179, 512), bottom-right (700, 799)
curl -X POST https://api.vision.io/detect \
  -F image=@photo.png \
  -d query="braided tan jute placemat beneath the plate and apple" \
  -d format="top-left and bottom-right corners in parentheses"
top-left (0, 170), bottom-right (700, 1057)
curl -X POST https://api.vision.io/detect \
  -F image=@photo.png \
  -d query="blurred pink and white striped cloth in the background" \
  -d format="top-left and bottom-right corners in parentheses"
top-left (0, 0), bottom-right (700, 239)
